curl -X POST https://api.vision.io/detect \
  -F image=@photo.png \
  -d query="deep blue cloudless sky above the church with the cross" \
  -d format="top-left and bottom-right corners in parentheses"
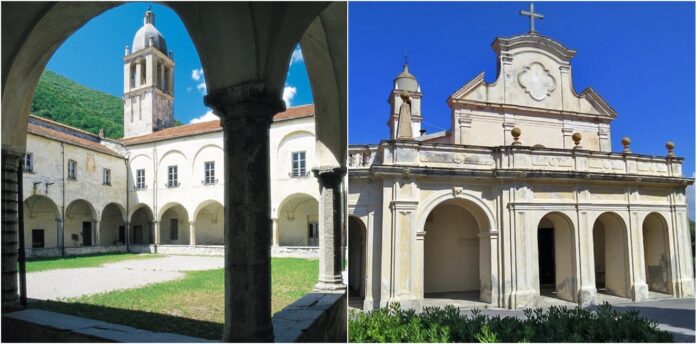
top-left (349, 2), bottom-right (695, 183)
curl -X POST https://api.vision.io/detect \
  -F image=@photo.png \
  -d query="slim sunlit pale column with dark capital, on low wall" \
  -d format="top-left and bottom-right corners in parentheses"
top-left (312, 167), bottom-right (346, 291)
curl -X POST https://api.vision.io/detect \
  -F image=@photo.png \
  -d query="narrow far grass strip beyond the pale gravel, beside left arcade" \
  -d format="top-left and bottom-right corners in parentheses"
top-left (27, 252), bottom-right (160, 272)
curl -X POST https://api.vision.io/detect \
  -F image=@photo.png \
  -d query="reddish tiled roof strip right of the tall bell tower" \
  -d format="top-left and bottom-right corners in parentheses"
top-left (119, 104), bottom-right (314, 145)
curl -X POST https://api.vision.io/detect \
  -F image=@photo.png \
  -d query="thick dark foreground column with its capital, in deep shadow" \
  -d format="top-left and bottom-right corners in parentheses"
top-left (205, 82), bottom-right (285, 342)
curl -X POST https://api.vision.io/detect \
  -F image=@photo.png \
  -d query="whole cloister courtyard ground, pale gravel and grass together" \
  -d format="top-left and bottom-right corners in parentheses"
top-left (19, 254), bottom-right (318, 340)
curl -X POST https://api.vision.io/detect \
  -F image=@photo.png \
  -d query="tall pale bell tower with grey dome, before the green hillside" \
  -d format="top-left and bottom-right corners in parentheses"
top-left (123, 8), bottom-right (174, 137)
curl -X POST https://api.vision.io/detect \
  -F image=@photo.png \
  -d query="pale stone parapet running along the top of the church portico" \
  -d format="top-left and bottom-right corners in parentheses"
top-left (362, 141), bottom-right (683, 177)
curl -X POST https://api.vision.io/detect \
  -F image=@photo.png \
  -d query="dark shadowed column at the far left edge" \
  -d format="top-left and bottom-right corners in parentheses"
top-left (2, 149), bottom-right (22, 314)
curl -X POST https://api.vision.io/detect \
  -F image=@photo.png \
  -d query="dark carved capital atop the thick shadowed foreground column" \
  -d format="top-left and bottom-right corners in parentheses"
top-left (203, 81), bottom-right (285, 126)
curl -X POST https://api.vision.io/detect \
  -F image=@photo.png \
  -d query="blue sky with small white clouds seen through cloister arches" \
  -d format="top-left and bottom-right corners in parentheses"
top-left (46, 2), bottom-right (312, 123)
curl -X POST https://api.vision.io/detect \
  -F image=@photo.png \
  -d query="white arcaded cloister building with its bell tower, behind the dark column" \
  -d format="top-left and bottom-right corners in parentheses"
top-left (23, 10), bottom-right (319, 257)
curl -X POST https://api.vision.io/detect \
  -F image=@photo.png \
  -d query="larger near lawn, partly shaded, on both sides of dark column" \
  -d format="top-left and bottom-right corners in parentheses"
top-left (30, 258), bottom-right (319, 339)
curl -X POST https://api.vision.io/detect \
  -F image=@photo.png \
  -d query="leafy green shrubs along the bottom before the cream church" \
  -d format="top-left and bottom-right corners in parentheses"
top-left (348, 303), bottom-right (672, 343)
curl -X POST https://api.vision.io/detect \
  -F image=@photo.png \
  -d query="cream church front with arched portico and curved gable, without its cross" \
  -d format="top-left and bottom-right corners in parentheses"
top-left (348, 29), bottom-right (694, 309)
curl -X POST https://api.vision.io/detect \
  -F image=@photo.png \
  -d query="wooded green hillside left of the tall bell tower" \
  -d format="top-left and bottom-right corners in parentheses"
top-left (31, 70), bottom-right (181, 138)
